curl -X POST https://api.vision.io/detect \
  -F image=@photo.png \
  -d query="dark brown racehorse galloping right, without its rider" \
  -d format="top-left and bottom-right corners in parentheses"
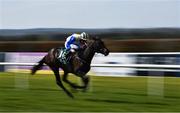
top-left (31, 37), bottom-right (109, 98)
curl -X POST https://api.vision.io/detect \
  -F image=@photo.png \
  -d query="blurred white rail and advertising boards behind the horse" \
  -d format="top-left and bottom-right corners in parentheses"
top-left (0, 52), bottom-right (180, 76)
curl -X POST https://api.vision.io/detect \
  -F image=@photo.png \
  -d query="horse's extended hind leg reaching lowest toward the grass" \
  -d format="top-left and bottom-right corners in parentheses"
top-left (51, 68), bottom-right (73, 98)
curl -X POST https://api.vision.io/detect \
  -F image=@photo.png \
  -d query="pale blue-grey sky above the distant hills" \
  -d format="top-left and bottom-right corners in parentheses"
top-left (0, 0), bottom-right (180, 29)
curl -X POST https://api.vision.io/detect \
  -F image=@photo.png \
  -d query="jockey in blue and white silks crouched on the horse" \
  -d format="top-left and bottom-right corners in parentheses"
top-left (65, 32), bottom-right (88, 53)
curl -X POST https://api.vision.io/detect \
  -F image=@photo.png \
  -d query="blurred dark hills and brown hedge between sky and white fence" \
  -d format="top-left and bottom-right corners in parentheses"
top-left (0, 28), bottom-right (180, 52)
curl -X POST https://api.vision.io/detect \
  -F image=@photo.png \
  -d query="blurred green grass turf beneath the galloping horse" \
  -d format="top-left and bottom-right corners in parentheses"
top-left (0, 73), bottom-right (180, 112)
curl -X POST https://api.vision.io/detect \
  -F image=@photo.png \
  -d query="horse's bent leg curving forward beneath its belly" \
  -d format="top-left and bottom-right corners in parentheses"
top-left (63, 71), bottom-right (85, 89)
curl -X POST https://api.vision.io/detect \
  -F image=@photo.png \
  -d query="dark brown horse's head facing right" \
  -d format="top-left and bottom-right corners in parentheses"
top-left (93, 37), bottom-right (109, 56)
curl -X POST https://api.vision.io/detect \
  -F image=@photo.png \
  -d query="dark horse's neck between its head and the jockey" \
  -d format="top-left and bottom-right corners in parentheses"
top-left (83, 42), bottom-right (95, 64)
